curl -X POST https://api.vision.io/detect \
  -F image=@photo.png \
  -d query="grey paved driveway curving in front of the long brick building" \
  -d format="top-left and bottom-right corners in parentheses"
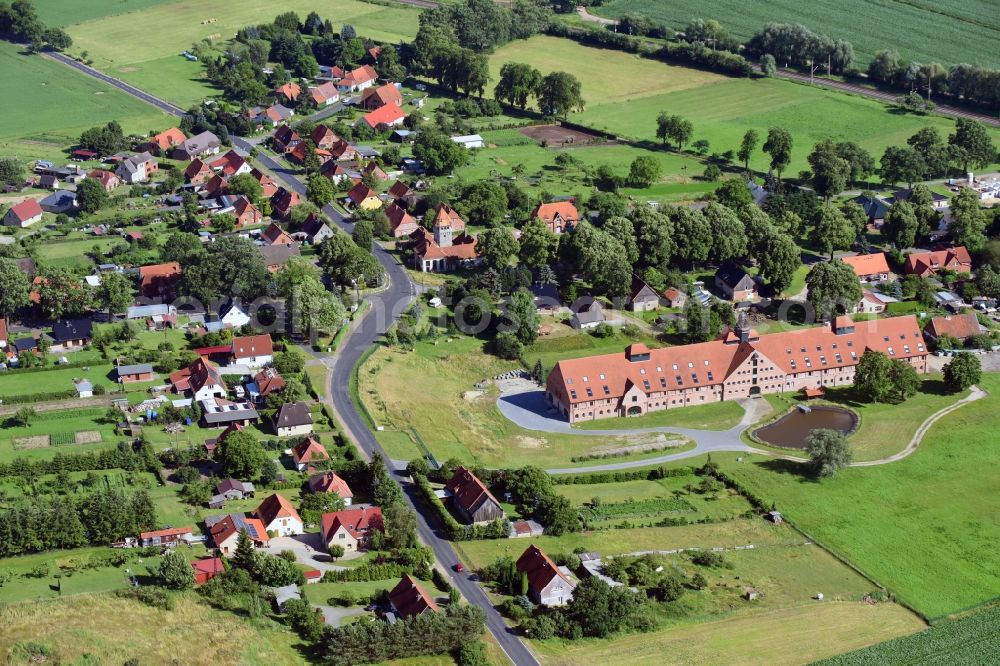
top-left (497, 390), bottom-right (770, 474)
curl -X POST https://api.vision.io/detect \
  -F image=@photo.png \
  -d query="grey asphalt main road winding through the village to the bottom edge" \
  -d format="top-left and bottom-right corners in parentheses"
top-left (46, 52), bottom-right (538, 666)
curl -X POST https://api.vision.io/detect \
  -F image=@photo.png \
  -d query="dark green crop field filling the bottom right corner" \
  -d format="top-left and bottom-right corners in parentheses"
top-left (816, 606), bottom-right (1000, 666)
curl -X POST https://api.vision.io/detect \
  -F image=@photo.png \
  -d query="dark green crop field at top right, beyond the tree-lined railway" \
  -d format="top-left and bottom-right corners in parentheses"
top-left (590, 0), bottom-right (1000, 67)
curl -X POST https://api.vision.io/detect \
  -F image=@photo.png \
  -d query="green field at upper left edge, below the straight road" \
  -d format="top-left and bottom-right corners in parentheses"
top-left (0, 42), bottom-right (169, 163)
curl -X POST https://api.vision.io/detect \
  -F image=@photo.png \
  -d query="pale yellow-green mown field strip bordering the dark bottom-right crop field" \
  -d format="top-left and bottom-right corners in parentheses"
top-left (532, 601), bottom-right (924, 666)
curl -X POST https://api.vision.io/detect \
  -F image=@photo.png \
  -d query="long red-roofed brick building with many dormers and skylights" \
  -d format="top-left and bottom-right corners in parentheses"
top-left (545, 315), bottom-right (927, 423)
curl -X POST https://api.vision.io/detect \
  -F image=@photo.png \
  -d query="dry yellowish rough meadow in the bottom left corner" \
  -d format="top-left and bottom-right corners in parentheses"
top-left (0, 592), bottom-right (304, 666)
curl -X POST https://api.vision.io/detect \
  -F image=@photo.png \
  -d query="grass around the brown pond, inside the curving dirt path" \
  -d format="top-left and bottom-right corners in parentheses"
top-left (766, 375), bottom-right (967, 460)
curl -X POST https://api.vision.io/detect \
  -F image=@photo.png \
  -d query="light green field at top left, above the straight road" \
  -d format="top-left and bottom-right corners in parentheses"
top-left (67, 0), bottom-right (418, 107)
